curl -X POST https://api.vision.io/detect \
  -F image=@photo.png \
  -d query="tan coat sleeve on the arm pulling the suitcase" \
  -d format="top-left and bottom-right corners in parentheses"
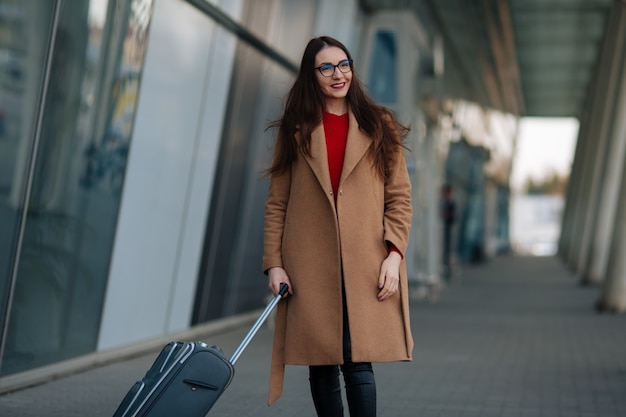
top-left (263, 166), bottom-right (291, 274)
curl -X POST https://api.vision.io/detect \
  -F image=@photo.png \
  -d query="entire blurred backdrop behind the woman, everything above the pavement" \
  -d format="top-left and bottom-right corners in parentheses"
top-left (0, 0), bottom-right (626, 392)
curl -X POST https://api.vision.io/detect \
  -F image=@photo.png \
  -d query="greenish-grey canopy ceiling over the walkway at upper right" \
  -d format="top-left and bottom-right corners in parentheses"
top-left (361, 0), bottom-right (621, 117)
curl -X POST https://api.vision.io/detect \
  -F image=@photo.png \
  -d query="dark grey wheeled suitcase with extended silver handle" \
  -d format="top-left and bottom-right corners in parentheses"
top-left (113, 284), bottom-right (288, 417)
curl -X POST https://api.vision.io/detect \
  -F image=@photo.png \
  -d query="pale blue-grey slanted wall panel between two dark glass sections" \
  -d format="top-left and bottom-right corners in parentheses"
top-left (98, 0), bottom-right (243, 349)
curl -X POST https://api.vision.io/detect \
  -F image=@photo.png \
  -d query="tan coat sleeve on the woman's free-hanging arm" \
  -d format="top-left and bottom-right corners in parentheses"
top-left (384, 148), bottom-right (413, 255)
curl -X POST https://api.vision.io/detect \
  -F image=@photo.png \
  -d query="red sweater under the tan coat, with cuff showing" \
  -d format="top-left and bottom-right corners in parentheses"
top-left (323, 112), bottom-right (403, 256)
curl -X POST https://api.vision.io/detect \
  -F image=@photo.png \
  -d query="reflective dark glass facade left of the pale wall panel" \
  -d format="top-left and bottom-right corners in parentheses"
top-left (0, 0), bottom-right (151, 375)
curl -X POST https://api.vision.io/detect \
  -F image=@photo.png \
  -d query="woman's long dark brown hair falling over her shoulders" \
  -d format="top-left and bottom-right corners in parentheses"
top-left (265, 36), bottom-right (409, 178)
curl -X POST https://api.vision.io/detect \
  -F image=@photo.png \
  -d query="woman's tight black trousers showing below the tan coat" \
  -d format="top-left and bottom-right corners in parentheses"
top-left (309, 294), bottom-right (376, 417)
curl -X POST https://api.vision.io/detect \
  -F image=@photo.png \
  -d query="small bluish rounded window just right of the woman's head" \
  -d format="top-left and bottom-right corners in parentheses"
top-left (368, 31), bottom-right (398, 105)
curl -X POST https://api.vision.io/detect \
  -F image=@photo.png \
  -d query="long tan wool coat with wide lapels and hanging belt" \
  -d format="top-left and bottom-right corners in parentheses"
top-left (263, 113), bottom-right (413, 404)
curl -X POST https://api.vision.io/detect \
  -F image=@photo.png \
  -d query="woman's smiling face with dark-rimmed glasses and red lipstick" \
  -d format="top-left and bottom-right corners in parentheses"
top-left (315, 46), bottom-right (352, 102)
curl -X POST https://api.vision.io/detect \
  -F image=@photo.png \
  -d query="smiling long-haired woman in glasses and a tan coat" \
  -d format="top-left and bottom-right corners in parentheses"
top-left (263, 36), bottom-right (413, 417)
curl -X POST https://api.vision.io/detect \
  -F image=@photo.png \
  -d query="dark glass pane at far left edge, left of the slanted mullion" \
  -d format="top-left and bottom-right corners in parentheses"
top-left (0, 0), bottom-right (55, 368)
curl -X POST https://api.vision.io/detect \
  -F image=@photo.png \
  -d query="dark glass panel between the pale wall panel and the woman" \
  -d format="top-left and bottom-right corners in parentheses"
top-left (192, 0), bottom-right (314, 324)
